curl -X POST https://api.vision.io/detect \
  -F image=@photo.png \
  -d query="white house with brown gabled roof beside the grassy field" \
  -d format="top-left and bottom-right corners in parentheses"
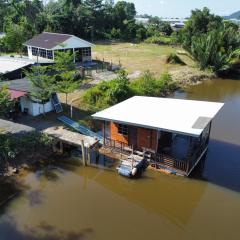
top-left (23, 32), bottom-right (93, 63)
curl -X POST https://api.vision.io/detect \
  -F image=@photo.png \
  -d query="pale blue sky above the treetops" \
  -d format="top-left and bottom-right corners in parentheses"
top-left (117, 0), bottom-right (240, 18)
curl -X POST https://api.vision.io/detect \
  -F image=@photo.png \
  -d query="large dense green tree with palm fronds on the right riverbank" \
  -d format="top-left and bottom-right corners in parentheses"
top-left (181, 8), bottom-right (240, 72)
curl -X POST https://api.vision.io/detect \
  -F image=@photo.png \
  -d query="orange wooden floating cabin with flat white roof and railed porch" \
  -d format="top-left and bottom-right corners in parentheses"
top-left (93, 96), bottom-right (224, 176)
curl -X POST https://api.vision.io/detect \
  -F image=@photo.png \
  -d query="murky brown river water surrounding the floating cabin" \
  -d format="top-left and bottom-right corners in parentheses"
top-left (0, 80), bottom-right (240, 240)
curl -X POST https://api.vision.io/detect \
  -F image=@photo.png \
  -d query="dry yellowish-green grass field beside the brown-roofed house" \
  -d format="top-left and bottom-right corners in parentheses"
top-left (93, 43), bottom-right (194, 75)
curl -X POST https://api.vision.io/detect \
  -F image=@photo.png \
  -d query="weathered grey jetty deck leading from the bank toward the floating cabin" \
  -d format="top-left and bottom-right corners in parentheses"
top-left (43, 127), bottom-right (99, 148)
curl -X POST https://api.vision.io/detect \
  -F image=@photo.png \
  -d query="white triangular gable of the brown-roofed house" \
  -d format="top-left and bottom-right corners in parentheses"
top-left (53, 36), bottom-right (93, 50)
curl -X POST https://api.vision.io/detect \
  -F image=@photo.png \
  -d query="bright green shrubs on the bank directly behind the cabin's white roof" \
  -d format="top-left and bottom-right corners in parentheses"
top-left (81, 71), bottom-right (175, 112)
